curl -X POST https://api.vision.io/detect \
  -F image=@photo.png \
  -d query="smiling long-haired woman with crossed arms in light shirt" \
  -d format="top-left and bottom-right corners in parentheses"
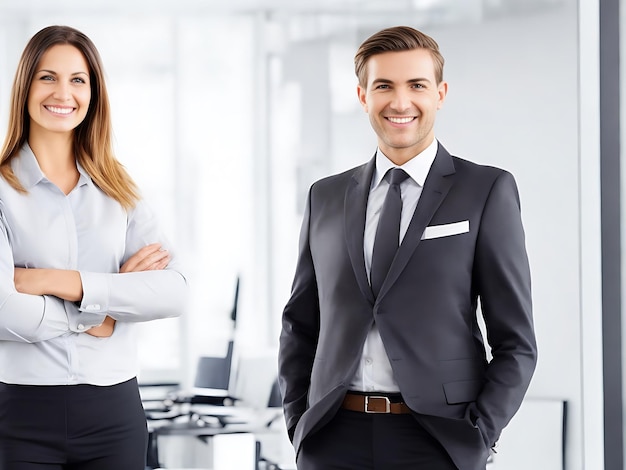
top-left (0, 26), bottom-right (187, 470)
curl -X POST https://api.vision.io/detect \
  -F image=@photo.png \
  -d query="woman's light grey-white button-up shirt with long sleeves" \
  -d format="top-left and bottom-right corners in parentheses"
top-left (0, 144), bottom-right (187, 385)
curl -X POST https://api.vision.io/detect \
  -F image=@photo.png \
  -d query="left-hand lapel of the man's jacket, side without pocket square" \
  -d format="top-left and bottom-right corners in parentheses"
top-left (344, 156), bottom-right (376, 304)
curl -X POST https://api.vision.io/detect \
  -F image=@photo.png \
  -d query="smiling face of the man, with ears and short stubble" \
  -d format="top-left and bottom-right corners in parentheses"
top-left (357, 49), bottom-right (448, 165)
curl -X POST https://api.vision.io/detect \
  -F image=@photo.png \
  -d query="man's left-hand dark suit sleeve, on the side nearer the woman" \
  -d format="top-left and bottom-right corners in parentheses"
top-left (278, 187), bottom-right (319, 438)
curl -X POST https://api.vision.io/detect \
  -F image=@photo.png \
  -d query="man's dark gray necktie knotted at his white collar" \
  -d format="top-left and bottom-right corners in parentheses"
top-left (370, 168), bottom-right (409, 297)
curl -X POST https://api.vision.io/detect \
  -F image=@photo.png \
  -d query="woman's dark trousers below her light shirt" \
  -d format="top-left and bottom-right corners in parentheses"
top-left (0, 379), bottom-right (148, 470)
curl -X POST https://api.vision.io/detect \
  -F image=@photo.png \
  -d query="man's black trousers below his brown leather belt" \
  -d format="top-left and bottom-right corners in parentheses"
top-left (297, 409), bottom-right (457, 470)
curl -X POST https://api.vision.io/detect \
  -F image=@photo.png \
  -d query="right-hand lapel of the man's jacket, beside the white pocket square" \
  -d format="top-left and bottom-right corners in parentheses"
top-left (378, 144), bottom-right (455, 299)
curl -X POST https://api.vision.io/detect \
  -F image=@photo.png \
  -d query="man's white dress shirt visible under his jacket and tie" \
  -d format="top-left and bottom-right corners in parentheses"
top-left (349, 139), bottom-right (437, 392)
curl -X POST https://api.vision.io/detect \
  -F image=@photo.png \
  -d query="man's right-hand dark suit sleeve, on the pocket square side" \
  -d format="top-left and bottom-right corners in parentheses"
top-left (469, 172), bottom-right (537, 446)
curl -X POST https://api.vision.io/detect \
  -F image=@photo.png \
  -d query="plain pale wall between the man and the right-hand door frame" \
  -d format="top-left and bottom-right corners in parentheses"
top-left (434, 5), bottom-right (600, 470)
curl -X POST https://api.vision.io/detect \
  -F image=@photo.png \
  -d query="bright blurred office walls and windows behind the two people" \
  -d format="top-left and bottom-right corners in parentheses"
top-left (0, 0), bottom-right (626, 470)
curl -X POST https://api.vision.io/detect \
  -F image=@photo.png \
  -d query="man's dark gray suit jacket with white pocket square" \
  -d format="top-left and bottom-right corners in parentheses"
top-left (279, 144), bottom-right (537, 470)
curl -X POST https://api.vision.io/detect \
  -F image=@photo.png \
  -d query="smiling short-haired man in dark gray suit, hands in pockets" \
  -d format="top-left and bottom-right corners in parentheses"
top-left (279, 27), bottom-right (537, 470)
